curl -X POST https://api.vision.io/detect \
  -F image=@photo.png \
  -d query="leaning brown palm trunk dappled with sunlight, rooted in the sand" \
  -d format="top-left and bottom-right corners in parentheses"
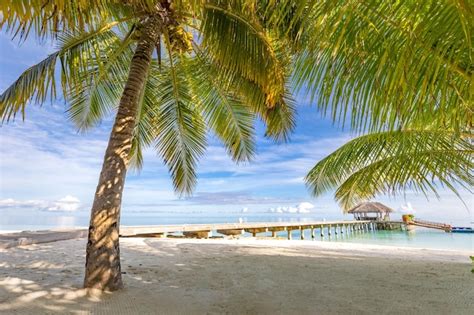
top-left (84, 21), bottom-right (159, 291)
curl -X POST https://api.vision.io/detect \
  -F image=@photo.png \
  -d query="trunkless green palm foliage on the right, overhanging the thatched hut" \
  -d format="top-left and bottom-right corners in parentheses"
top-left (295, 0), bottom-right (474, 210)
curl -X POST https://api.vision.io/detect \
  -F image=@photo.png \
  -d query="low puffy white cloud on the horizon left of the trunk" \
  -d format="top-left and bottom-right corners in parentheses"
top-left (0, 195), bottom-right (81, 212)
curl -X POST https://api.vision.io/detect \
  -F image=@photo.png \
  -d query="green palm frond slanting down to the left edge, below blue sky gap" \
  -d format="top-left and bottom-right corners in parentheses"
top-left (0, 22), bottom-right (124, 121)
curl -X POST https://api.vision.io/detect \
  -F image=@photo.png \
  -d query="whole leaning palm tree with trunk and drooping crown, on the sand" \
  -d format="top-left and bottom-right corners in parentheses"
top-left (0, 0), bottom-right (294, 290)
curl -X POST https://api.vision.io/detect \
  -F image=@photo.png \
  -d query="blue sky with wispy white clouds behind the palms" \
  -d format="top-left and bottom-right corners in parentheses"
top-left (0, 33), bottom-right (473, 230)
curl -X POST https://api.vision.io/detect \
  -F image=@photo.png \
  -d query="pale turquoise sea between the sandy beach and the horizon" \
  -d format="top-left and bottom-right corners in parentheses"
top-left (0, 211), bottom-right (474, 254)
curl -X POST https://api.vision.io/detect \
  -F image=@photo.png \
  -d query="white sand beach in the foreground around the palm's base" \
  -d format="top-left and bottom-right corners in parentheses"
top-left (0, 238), bottom-right (474, 314)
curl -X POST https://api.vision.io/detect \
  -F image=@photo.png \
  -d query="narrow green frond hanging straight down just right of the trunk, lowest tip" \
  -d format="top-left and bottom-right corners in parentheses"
top-left (152, 46), bottom-right (206, 195)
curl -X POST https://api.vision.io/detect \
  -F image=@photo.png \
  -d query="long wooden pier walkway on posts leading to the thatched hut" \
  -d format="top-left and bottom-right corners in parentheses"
top-left (120, 220), bottom-right (377, 240)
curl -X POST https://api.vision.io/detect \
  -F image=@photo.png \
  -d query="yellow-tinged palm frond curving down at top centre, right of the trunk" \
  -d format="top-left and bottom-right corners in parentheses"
top-left (200, 0), bottom-right (286, 107)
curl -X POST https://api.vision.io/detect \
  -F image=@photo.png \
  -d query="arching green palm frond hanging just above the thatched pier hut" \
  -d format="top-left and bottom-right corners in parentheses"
top-left (305, 130), bottom-right (474, 209)
